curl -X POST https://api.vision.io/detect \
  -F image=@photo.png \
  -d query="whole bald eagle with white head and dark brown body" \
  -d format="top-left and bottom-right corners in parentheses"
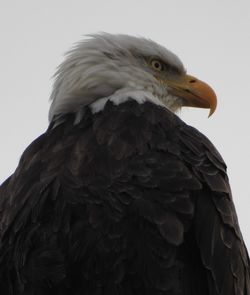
top-left (0, 33), bottom-right (250, 295)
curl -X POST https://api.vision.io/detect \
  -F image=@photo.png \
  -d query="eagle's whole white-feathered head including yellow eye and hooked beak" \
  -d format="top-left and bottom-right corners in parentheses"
top-left (49, 33), bottom-right (217, 121)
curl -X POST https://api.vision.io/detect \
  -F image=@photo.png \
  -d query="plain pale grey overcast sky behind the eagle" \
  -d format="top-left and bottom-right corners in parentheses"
top-left (0, 0), bottom-right (250, 249)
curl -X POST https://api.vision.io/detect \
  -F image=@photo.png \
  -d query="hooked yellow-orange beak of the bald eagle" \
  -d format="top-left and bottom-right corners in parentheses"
top-left (166, 75), bottom-right (217, 117)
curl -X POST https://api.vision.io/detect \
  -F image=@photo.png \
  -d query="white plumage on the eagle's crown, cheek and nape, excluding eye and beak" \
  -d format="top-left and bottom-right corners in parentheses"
top-left (49, 33), bottom-right (184, 121)
